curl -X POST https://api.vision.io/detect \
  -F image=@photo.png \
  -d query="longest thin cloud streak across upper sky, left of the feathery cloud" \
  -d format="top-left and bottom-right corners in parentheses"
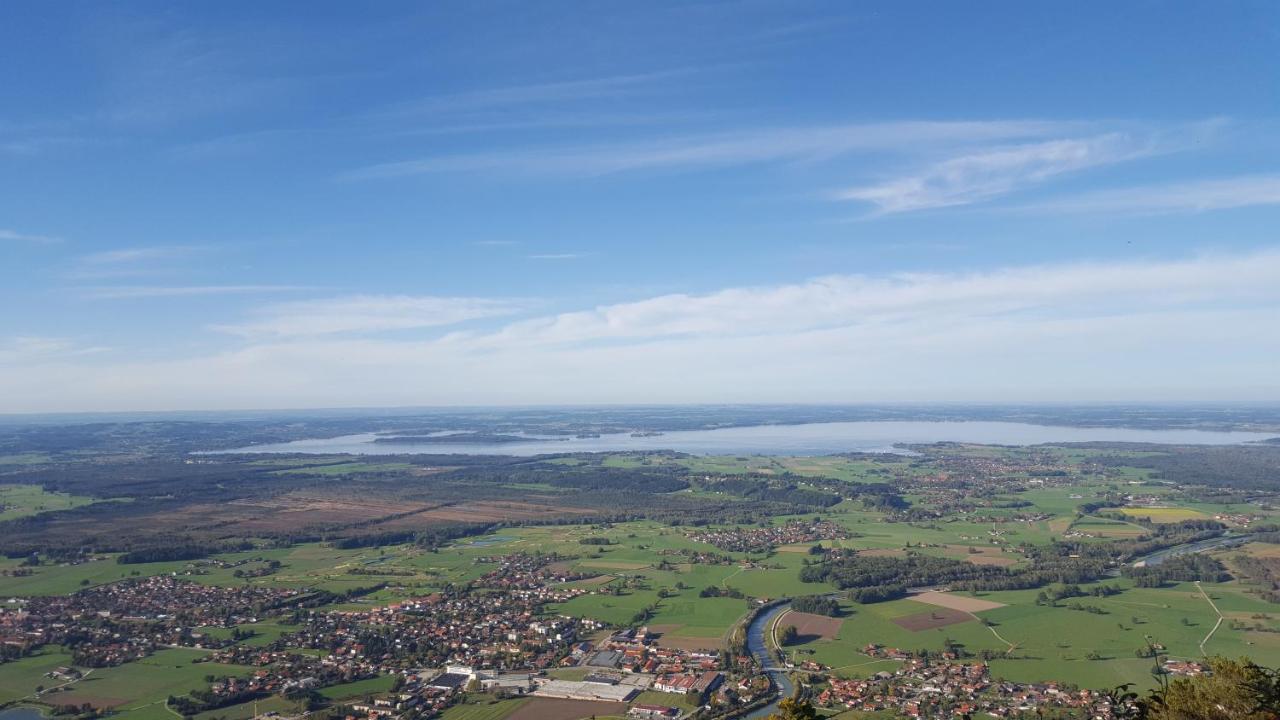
top-left (340, 120), bottom-right (1083, 179)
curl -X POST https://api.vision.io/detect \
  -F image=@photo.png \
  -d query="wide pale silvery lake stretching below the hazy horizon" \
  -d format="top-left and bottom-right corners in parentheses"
top-left (207, 421), bottom-right (1275, 456)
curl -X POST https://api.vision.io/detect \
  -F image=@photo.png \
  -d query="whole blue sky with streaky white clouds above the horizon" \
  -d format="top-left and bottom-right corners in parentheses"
top-left (0, 0), bottom-right (1280, 413)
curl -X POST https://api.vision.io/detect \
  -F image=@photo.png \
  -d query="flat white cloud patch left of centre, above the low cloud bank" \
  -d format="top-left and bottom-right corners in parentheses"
top-left (215, 295), bottom-right (524, 338)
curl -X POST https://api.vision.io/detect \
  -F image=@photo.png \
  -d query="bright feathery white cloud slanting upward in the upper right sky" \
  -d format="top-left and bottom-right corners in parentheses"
top-left (836, 133), bottom-right (1155, 215)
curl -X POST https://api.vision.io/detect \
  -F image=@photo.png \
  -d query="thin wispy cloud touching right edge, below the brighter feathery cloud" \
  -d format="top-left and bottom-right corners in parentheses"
top-left (1015, 176), bottom-right (1280, 215)
